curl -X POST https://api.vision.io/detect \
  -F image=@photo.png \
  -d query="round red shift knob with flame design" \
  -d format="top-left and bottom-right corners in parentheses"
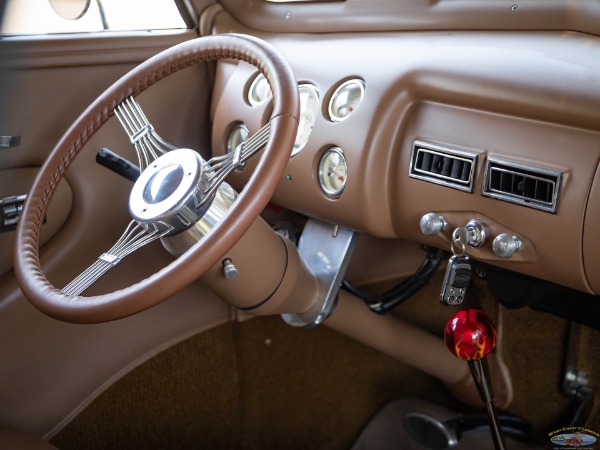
top-left (444, 309), bottom-right (496, 361)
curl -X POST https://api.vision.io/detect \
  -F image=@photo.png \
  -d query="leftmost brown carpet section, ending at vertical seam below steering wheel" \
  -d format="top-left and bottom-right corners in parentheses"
top-left (52, 327), bottom-right (240, 450)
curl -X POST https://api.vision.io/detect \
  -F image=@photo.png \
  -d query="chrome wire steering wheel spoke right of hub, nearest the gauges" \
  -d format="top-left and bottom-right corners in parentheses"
top-left (198, 123), bottom-right (271, 208)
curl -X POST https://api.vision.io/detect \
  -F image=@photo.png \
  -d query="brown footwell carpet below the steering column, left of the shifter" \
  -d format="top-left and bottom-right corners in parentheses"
top-left (52, 317), bottom-right (450, 450)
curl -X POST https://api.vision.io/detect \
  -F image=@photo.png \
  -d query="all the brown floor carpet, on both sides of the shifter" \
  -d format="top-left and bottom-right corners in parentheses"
top-left (52, 270), bottom-right (600, 450)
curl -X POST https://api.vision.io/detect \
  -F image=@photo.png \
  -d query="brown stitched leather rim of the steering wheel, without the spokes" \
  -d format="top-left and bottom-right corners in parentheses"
top-left (15, 34), bottom-right (300, 323)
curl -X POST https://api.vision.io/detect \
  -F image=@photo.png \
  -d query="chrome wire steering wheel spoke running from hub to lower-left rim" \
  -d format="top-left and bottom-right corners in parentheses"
top-left (61, 220), bottom-right (172, 296)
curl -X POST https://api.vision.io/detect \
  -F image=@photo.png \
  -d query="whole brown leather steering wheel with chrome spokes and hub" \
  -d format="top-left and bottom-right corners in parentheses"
top-left (15, 34), bottom-right (299, 323)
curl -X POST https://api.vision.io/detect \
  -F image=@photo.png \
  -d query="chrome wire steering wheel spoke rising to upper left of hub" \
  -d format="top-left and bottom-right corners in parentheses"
top-left (115, 97), bottom-right (177, 172)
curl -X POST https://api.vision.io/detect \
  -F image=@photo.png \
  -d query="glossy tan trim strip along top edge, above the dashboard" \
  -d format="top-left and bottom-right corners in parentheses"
top-left (220, 0), bottom-right (600, 35)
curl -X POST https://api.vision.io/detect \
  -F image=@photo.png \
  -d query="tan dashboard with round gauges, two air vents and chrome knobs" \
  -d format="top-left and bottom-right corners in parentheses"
top-left (212, 14), bottom-right (600, 294)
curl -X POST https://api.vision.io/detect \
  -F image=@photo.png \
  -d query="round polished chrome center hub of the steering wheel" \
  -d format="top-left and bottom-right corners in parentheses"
top-left (129, 148), bottom-right (210, 234)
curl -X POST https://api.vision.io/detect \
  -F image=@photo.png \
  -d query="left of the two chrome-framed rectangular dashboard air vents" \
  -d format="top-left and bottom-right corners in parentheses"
top-left (409, 141), bottom-right (477, 192)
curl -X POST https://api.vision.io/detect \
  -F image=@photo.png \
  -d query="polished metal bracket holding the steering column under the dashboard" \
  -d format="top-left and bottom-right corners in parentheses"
top-left (282, 219), bottom-right (358, 327)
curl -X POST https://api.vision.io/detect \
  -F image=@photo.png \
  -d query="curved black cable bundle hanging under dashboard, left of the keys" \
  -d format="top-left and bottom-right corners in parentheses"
top-left (342, 246), bottom-right (446, 315)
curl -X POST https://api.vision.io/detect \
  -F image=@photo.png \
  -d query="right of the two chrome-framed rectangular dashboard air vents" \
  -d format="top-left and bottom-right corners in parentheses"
top-left (483, 158), bottom-right (563, 213)
